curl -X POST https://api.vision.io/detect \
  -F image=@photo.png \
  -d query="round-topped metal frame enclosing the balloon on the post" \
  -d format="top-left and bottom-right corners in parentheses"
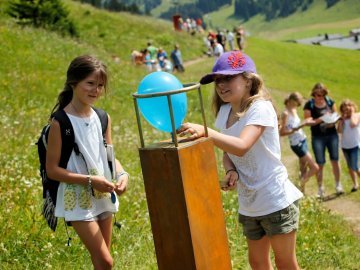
top-left (133, 83), bottom-right (208, 148)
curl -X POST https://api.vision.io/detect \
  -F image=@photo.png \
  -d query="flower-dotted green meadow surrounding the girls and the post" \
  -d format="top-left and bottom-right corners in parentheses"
top-left (0, 1), bottom-right (360, 270)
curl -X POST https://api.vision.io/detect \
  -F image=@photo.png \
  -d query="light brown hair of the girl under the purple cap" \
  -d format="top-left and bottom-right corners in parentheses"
top-left (212, 72), bottom-right (271, 117)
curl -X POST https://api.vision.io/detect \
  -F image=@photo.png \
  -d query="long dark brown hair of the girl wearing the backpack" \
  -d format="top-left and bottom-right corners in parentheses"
top-left (51, 55), bottom-right (107, 115)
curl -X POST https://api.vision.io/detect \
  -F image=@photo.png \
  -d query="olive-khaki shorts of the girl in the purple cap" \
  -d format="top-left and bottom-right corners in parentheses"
top-left (239, 201), bottom-right (300, 240)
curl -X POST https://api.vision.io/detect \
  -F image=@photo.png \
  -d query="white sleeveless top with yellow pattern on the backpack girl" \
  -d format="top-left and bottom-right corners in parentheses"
top-left (55, 110), bottom-right (119, 221)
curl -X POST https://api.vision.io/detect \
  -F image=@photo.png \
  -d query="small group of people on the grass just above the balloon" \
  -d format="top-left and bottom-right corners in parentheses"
top-left (131, 42), bottom-right (185, 73)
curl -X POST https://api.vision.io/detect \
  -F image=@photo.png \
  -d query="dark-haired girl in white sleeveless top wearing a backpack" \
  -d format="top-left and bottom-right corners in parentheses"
top-left (46, 55), bottom-right (129, 269)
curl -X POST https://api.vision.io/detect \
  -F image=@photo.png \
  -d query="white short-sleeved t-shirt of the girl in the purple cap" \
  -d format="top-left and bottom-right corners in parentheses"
top-left (215, 100), bottom-right (303, 217)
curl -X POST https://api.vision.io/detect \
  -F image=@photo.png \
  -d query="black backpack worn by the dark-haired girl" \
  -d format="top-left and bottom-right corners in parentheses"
top-left (36, 108), bottom-right (108, 231)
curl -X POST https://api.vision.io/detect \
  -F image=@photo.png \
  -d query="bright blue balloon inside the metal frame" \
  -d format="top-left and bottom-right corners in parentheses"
top-left (138, 71), bottom-right (187, 132)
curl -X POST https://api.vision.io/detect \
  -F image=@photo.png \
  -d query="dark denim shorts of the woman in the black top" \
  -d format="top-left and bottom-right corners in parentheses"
top-left (311, 133), bottom-right (339, 165)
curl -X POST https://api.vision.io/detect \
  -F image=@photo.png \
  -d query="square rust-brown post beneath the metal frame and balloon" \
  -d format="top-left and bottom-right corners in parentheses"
top-left (139, 138), bottom-right (231, 270)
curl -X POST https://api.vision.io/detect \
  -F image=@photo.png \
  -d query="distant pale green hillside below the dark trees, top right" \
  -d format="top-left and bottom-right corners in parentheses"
top-left (205, 0), bottom-right (360, 40)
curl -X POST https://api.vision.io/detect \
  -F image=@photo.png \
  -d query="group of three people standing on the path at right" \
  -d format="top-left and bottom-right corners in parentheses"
top-left (280, 83), bottom-right (360, 198)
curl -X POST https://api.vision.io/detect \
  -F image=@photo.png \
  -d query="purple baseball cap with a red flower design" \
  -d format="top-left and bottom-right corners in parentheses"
top-left (200, 51), bottom-right (256, 84)
